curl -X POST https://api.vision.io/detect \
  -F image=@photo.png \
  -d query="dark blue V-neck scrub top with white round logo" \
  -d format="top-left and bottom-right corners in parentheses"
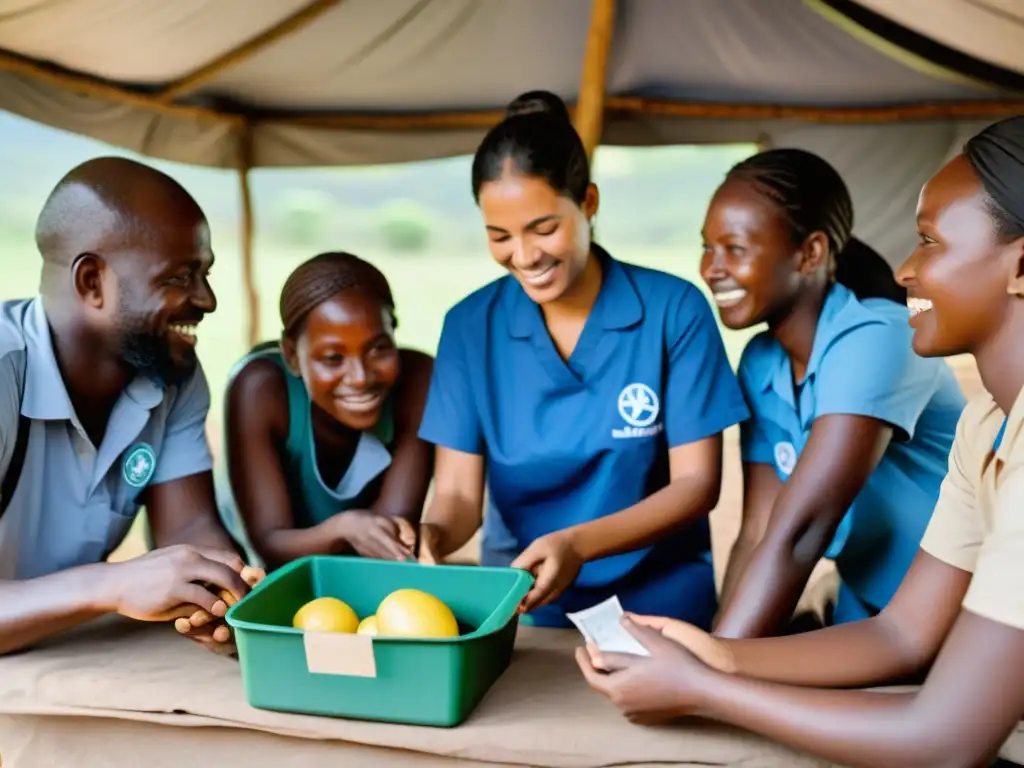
top-left (420, 247), bottom-right (749, 602)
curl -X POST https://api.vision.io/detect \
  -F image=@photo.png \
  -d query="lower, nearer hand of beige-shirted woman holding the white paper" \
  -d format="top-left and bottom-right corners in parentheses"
top-left (575, 616), bottom-right (709, 724)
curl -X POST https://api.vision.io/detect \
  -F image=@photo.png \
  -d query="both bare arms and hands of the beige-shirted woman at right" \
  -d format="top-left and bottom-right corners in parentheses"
top-left (578, 553), bottom-right (1024, 768)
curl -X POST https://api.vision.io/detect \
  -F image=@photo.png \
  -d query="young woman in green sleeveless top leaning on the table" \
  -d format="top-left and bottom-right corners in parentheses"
top-left (221, 253), bottom-right (433, 568)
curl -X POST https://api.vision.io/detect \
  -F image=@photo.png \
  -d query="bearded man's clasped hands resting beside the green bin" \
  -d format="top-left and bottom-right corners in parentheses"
top-left (106, 545), bottom-right (265, 653)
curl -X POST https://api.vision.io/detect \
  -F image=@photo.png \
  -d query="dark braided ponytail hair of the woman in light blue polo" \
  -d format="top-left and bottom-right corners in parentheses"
top-left (726, 148), bottom-right (906, 304)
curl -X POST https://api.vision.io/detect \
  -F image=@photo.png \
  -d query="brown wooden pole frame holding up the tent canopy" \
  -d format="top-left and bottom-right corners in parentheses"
top-left (0, 26), bottom-right (1024, 352)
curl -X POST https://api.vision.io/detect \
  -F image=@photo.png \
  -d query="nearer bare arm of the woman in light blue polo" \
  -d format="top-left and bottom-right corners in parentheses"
top-left (715, 415), bottom-right (893, 638)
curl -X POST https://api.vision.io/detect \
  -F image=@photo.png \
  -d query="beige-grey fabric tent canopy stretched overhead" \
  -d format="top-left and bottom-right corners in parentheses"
top-left (0, 0), bottom-right (1024, 168)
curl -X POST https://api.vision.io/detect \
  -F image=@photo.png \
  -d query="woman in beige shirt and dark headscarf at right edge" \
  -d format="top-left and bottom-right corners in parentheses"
top-left (577, 117), bottom-right (1024, 768)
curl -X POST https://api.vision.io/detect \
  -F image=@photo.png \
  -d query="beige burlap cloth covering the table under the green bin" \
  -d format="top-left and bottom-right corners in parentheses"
top-left (0, 618), bottom-right (839, 768)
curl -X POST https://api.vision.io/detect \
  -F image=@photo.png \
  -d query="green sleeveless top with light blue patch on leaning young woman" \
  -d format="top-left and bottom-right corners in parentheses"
top-left (219, 341), bottom-right (395, 549)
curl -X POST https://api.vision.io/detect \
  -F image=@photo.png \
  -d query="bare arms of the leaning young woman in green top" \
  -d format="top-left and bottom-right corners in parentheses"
top-left (227, 350), bottom-right (433, 567)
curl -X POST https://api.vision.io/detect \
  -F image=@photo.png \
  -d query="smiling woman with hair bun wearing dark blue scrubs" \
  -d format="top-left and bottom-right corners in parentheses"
top-left (420, 92), bottom-right (749, 627)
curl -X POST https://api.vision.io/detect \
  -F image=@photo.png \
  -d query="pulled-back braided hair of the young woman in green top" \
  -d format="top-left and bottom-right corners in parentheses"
top-left (280, 251), bottom-right (398, 339)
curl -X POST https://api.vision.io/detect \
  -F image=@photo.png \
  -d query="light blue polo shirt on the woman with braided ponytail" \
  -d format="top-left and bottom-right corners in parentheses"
top-left (739, 285), bottom-right (966, 621)
